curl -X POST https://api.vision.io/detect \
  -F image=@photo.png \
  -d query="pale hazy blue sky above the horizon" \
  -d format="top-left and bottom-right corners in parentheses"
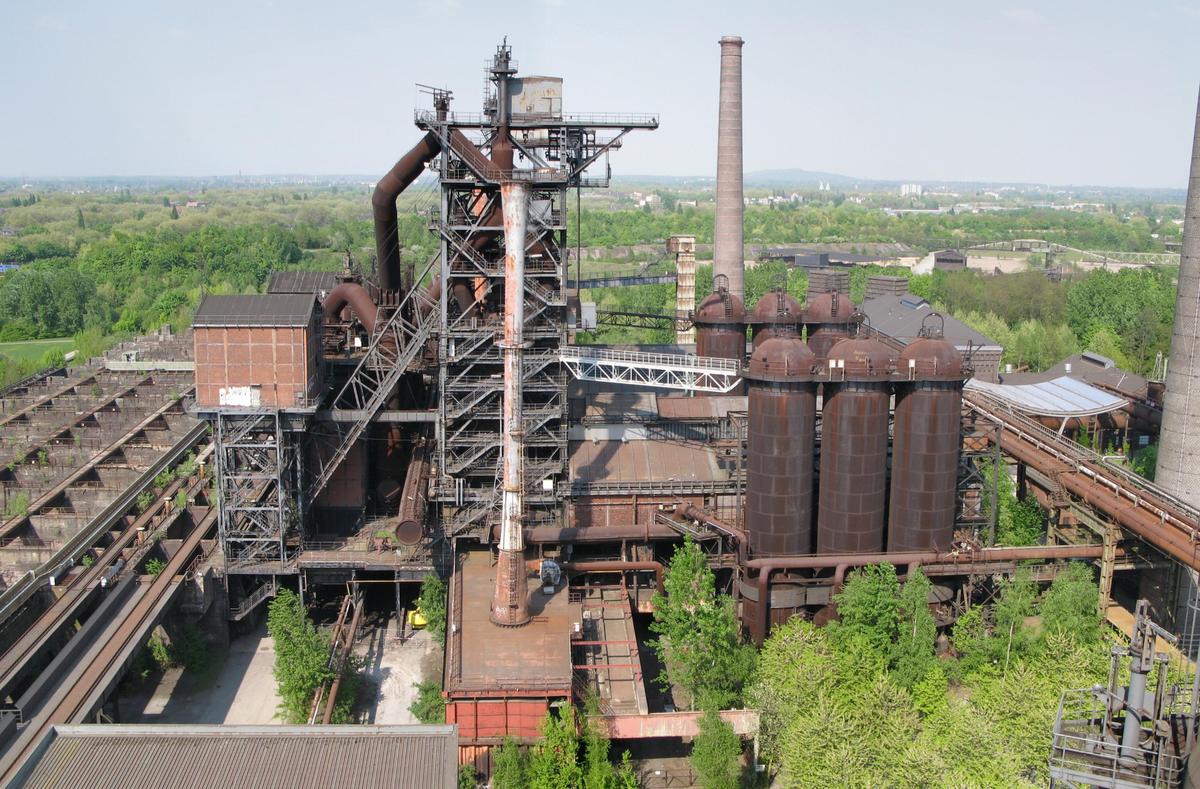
top-left (7, 0), bottom-right (1200, 187)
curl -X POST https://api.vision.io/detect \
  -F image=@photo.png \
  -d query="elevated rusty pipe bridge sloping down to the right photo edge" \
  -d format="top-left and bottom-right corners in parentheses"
top-left (962, 391), bottom-right (1200, 571)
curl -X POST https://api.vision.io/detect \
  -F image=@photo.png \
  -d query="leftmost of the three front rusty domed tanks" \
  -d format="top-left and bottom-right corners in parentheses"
top-left (743, 327), bottom-right (816, 636)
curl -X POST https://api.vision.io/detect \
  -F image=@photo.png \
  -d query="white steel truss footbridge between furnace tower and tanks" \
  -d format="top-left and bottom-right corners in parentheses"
top-left (559, 345), bottom-right (742, 393)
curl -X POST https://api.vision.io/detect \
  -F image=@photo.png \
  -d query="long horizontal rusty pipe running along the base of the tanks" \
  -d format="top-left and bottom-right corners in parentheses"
top-left (745, 546), bottom-right (1104, 644)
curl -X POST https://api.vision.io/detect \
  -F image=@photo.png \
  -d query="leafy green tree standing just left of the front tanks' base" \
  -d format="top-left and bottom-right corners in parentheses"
top-left (650, 538), bottom-right (755, 707)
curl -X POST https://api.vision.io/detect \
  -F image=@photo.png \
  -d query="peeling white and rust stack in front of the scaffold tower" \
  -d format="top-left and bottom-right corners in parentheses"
top-left (492, 181), bottom-right (529, 627)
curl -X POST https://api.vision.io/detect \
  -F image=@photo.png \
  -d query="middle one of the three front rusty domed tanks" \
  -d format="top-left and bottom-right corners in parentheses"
top-left (817, 337), bottom-right (895, 554)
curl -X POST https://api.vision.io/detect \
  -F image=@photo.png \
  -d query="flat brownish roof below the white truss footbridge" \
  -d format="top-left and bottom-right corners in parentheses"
top-left (570, 441), bottom-right (730, 482)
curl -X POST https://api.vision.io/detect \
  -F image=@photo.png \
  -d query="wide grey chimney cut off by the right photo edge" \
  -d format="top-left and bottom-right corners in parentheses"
top-left (1154, 84), bottom-right (1200, 506)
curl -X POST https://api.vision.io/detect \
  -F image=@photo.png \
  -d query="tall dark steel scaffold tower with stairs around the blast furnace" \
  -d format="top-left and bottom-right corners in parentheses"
top-left (415, 39), bottom-right (658, 541)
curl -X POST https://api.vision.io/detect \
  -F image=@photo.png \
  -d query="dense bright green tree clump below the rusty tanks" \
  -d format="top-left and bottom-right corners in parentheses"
top-left (748, 564), bottom-right (1108, 787)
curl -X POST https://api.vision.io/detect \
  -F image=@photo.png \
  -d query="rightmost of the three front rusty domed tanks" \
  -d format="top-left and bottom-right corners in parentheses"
top-left (888, 313), bottom-right (964, 550)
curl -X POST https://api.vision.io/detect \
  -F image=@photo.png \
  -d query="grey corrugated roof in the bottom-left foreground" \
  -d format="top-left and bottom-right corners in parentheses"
top-left (11, 725), bottom-right (458, 789)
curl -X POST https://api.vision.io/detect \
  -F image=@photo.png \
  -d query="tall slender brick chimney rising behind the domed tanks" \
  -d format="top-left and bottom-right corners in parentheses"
top-left (713, 36), bottom-right (745, 300)
